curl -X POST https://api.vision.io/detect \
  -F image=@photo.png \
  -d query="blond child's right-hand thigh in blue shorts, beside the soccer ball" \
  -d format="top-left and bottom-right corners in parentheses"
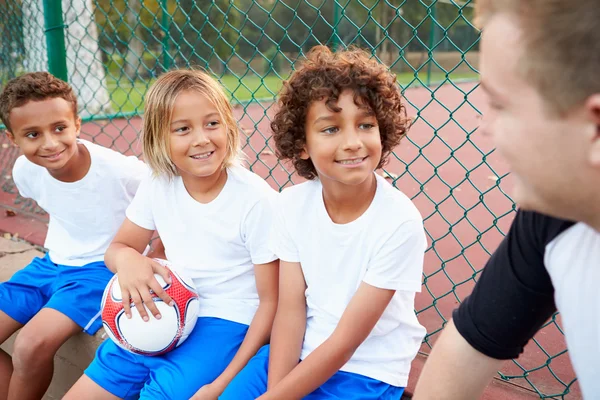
top-left (140, 317), bottom-right (248, 400)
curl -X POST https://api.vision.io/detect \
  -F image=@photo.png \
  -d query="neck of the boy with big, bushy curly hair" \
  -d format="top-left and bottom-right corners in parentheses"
top-left (321, 174), bottom-right (377, 224)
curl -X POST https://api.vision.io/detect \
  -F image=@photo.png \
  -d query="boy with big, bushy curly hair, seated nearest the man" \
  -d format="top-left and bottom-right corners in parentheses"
top-left (220, 46), bottom-right (427, 400)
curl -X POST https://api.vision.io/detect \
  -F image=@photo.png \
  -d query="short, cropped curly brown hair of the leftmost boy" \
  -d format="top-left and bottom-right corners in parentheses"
top-left (0, 72), bottom-right (77, 132)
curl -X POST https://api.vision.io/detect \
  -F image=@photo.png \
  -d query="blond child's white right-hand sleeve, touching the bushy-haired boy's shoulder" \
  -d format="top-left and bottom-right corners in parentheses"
top-left (243, 191), bottom-right (277, 265)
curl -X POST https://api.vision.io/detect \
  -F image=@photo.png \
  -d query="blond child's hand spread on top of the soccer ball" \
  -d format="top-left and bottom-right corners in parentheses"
top-left (117, 252), bottom-right (175, 321)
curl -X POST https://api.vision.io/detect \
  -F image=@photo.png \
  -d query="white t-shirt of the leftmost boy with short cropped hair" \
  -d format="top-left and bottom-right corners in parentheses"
top-left (13, 140), bottom-right (149, 266)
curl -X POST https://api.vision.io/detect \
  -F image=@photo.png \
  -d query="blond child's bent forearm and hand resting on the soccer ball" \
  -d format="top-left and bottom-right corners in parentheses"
top-left (104, 218), bottom-right (173, 321)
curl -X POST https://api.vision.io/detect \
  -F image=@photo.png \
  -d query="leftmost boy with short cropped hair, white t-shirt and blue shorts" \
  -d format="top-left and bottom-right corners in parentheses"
top-left (0, 72), bottom-right (148, 400)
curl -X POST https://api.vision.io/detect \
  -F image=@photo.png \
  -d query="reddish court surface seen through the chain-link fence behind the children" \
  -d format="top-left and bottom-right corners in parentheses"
top-left (0, 83), bottom-right (581, 399)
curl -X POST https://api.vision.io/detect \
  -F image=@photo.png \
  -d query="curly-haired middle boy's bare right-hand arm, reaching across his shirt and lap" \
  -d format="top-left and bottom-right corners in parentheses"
top-left (259, 282), bottom-right (395, 400)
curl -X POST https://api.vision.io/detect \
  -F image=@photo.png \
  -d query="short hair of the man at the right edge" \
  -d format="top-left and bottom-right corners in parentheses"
top-left (476, 0), bottom-right (600, 113)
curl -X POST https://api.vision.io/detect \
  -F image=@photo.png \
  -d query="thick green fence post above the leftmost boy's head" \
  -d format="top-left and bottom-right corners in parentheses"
top-left (43, 0), bottom-right (69, 82)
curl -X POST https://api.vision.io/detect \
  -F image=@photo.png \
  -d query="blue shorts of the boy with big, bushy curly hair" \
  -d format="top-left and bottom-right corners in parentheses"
top-left (219, 345), bottom-right (404, 400)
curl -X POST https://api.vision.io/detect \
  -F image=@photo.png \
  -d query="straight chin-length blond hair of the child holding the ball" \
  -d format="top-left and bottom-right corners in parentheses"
top-left (142, 70), bottom-right (241, 178)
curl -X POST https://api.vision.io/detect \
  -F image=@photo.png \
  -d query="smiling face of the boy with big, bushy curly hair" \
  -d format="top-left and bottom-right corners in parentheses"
top-left (301, 90), bottom-right (382, 190)
